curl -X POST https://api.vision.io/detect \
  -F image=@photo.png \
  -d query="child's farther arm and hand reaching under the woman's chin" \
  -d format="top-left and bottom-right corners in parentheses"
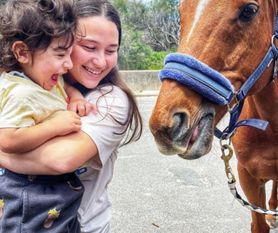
top-left (64, 82), bottom-right (96, 116)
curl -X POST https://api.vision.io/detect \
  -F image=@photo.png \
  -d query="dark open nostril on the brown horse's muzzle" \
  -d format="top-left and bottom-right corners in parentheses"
top-left (169, 112), bottom-right (188, 142)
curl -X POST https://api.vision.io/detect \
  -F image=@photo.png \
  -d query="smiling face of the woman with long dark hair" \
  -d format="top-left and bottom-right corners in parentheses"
top-left (69, 16), bottom-right (119, 89)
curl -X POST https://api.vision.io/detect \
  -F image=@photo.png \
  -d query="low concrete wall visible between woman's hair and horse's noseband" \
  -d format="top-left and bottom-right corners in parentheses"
top-left (120, 70), bottom-right (160, 95)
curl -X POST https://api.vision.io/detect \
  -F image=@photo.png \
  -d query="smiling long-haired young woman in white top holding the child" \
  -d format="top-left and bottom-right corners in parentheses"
top-left (0, 0), bottom-right (142, 233)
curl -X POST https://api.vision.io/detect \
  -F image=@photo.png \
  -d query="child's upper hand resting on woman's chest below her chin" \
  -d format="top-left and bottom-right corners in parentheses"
top-left (68, 99), bottom-right (97, 117)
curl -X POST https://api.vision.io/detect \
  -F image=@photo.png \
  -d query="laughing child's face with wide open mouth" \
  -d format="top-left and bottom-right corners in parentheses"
top-left (22, 39), bottom-right (72, 90)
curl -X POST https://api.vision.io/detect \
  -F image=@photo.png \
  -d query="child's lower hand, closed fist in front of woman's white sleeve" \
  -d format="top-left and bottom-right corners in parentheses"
top-left (47, 111), bottom-right (81, 136)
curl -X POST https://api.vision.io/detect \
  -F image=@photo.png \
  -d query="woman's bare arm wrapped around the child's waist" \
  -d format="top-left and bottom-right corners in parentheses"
top-left (0, 131), bottom-right (98, 175)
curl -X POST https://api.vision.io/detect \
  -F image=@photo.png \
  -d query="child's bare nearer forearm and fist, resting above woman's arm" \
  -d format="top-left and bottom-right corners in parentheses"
top-left (0, 111), bottom-right (81, 153)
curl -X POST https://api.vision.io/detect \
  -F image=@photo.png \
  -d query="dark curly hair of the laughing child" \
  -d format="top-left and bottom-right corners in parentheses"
top-left (0, 0), bottom-right (77, 71)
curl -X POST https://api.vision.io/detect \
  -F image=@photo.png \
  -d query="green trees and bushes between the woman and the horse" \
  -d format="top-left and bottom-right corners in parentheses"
top-left (112, 0), bottom-right (178, 70)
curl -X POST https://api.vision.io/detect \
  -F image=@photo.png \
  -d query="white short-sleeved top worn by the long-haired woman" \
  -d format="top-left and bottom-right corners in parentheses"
top-left (77, 85), bottom-right (129, 233)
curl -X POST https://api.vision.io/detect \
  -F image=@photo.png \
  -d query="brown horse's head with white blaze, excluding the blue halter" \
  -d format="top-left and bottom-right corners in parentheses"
top-left (150, 0), bottom-right (278, 159)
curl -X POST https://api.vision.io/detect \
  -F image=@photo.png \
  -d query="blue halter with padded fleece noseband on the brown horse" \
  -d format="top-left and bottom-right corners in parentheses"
top-left (159, 16), bottom-right (278, 139)
